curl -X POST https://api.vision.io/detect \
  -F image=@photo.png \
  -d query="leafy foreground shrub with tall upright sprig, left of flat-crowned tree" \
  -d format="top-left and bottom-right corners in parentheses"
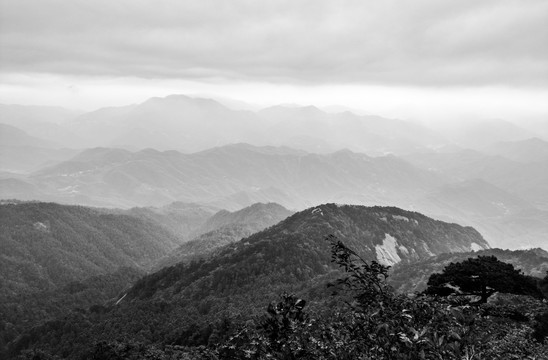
top-left (322, 236), bottom-right (484, 359)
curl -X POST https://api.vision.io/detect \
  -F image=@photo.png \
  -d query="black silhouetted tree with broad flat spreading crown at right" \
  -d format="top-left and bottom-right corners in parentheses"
top-left (426, 256), bottom-right (538, 303)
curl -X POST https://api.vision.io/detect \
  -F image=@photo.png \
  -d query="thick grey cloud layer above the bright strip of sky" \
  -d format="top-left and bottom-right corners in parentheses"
top-left (0, 0), bottom-right (548, 87)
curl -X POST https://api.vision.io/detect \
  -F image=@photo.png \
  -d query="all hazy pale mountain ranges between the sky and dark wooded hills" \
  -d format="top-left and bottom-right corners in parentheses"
top-left (0, 95), bottom-right (548, 248)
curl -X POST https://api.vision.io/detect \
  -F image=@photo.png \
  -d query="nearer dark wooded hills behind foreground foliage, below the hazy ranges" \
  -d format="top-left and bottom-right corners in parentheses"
top-left (0, 197), bottom-right (548, 358)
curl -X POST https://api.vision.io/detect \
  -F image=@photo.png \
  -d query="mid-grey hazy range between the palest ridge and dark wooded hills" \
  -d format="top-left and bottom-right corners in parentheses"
top-left (0, 144), bottom-right (548, 248)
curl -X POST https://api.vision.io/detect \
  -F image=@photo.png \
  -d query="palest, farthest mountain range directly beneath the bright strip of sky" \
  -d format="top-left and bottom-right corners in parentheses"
top-left (0, 95), bottom-right (547, 155)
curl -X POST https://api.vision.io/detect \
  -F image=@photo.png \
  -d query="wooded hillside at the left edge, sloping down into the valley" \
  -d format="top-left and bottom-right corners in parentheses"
top-left (0, 202), bottom-right (179, 294)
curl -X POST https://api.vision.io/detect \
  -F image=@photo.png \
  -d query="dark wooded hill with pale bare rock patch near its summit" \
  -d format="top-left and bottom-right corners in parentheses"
top-left (3, 204), bottom-right (488, 357)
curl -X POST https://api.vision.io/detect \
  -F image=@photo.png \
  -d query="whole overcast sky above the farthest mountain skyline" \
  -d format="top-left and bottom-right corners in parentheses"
top-left (0, 0), bottom-right (548, 121)
